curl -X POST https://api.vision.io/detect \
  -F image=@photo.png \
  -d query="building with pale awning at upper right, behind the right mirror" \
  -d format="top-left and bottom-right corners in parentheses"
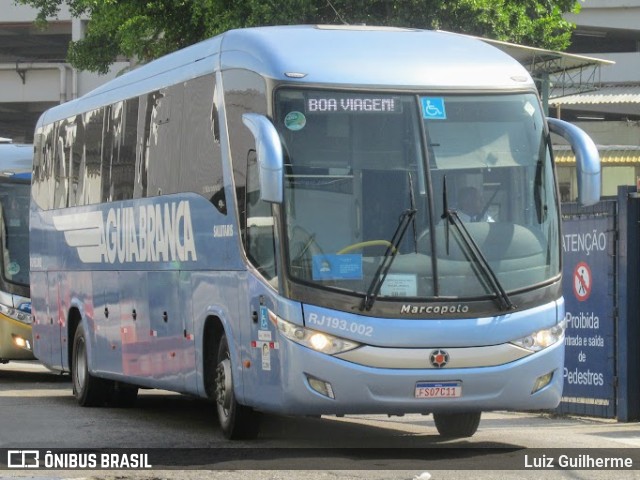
top-left (550, 0), bottom-right (640, 200)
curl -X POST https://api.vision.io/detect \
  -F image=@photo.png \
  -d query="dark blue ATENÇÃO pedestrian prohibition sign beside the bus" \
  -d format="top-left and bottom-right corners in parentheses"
top-left (559, 205), bottom-right (618, 418)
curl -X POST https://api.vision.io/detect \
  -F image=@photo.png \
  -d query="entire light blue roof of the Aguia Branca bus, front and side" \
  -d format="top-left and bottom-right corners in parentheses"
top-left (38, 25), bottom-right (535, 125)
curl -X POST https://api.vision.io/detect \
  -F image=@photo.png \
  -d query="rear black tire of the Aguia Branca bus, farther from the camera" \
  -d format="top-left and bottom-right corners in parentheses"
top-left (71, 324), bottom-right (110, 407)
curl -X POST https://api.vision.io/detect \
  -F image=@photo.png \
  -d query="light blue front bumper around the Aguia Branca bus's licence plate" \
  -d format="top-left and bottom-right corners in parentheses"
top-left (248, 339), bottom-right (564, 415)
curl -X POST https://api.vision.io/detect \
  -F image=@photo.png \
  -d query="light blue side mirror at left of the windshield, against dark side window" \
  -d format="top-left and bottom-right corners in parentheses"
top-left (242, 113), bottom-right (284, 203)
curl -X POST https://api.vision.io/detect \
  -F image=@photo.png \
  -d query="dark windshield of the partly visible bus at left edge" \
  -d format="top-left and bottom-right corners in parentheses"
top-left (0, 181), bottom-right (31, 285)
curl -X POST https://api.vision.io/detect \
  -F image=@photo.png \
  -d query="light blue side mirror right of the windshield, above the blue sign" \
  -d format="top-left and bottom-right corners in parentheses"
top-left (547, 118), bottom-right (601, 207)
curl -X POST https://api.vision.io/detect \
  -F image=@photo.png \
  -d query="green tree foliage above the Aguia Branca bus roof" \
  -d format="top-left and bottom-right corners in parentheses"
top-left (15, 0), bottom-right (580, 73)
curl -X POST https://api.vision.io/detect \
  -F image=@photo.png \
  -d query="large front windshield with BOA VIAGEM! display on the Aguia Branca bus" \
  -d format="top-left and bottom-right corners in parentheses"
top-left (275, 88), bottom-right (560, 299)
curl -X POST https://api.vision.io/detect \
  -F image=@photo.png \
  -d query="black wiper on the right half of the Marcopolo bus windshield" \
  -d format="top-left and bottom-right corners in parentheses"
top-left (441, 176), bottom-right (516, 310)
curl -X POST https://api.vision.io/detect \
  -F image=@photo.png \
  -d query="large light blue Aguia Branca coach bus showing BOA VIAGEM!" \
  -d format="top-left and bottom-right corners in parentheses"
top-left (30, 26), bottom-right (600, 438)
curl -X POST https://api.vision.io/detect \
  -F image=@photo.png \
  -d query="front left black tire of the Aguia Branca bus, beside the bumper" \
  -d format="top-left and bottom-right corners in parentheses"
top-left (215, 334), bottom-right (260, 440)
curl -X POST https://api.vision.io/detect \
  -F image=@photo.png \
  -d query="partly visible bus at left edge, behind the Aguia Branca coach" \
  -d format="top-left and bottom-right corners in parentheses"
top-left (0, 138), bottom-right (34, 363)
